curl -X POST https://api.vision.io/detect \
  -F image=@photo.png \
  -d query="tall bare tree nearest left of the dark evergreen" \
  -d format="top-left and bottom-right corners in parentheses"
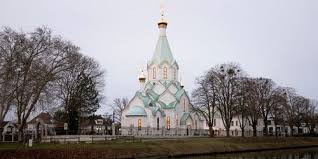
top-left (15, 28), bottom-right (78, 140)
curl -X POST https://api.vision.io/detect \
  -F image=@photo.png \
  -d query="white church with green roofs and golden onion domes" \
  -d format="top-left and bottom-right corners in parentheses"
top-left (121, 11), bottom-right (206, 136)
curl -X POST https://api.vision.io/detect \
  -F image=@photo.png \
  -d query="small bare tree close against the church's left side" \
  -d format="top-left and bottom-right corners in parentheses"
top-left (111, 98), bottom-right (128, 123)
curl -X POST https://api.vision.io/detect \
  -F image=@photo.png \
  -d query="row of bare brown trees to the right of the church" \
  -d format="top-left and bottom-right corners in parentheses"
top-left (192, 63), bottom-right (318, 137)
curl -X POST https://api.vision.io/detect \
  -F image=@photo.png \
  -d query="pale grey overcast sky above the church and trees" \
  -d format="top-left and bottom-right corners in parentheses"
top-left (0, 0), bottom-right (318, 113)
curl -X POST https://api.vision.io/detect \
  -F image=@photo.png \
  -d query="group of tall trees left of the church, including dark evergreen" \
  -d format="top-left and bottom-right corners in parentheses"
top-left (0, 27), bottom-right (104, 141)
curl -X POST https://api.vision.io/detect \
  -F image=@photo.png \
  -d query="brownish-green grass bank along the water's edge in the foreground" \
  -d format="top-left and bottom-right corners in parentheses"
top-left (0, 137), bottom-right (318, 159)
